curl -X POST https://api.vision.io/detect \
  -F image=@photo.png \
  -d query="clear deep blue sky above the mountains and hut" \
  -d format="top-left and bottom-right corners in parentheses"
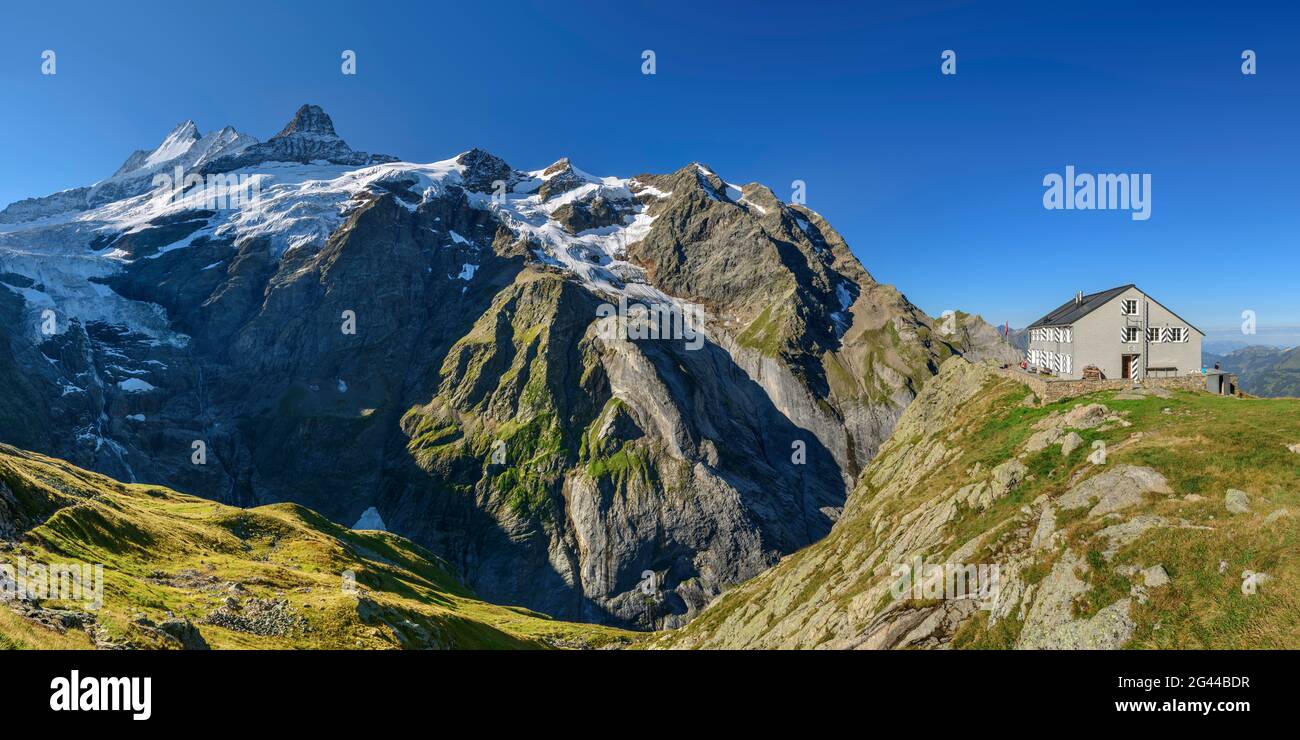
top-left (0, 0), bottom-right (1300, 329)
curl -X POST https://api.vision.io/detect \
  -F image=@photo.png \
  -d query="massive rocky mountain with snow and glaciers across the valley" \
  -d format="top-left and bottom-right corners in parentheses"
top-left (0, 107), bottom-right (1008, 626)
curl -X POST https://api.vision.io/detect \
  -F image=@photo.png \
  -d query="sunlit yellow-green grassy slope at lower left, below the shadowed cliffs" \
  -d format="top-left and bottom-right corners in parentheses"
top-left (0, 446), bottom-right (631, 649)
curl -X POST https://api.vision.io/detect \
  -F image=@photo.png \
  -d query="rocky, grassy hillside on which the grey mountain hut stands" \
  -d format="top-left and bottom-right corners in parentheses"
top-left (651, 358), bottom-right (1300, 649)
